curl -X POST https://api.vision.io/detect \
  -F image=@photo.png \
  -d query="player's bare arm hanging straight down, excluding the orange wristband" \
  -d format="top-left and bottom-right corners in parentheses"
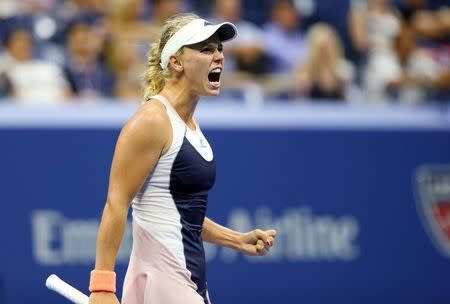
top-left (90, 103), bottom-right (172, 303)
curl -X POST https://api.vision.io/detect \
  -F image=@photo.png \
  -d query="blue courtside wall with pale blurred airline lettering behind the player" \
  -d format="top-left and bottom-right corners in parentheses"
top-left (0, 103), bottom-right (450, 304)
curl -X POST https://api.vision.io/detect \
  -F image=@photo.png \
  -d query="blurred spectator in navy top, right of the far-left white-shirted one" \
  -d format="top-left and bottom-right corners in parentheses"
top-left (64, 18), bottom-right (113, 98)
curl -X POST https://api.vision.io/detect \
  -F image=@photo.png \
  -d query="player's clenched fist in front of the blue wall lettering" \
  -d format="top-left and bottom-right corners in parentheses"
top-left (239, 229), bottom-right (277, 256)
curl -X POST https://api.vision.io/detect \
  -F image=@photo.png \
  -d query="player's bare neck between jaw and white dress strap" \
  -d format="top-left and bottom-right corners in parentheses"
top-left (160, 81), bottom-right (200, 129)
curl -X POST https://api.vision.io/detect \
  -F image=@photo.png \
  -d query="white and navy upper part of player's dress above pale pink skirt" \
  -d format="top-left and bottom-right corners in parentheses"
top-left (132, 95), bottom-right (215, 300)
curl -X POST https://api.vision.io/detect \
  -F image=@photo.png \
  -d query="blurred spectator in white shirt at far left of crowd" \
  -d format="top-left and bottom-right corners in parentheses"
top-left (0, 27), bottom-right (72, 103)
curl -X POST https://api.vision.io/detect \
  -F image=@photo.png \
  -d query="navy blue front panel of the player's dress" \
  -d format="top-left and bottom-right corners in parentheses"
top-left (170, 137), bottom-right (216, 303)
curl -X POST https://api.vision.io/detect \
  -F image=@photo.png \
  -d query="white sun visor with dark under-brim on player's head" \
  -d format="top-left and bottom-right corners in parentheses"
top-left (161, 19), bottom-right (237, 69)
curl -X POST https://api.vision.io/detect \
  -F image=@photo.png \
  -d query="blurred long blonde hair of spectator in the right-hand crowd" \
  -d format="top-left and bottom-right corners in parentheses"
top-left (307, 22), bottom-right (343, 64)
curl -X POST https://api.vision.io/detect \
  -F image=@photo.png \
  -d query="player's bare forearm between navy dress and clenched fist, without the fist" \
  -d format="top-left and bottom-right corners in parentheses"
top-left (202, 217), bottom-right (242, 250)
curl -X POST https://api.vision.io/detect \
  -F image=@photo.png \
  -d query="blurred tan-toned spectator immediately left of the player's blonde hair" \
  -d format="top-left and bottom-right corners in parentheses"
top-left (106, 39), bottom-right (146, 102)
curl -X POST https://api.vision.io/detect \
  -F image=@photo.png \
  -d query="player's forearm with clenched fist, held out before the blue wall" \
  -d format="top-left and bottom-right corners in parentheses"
top-left (202, 218), bottom-right (276, 255)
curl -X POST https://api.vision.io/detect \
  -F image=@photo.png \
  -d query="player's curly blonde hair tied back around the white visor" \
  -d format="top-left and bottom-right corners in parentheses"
top-left (144, 13), bottom-right (200, 100)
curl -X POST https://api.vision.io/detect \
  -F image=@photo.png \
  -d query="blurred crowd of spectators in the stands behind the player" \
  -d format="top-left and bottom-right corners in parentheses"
top-left (0, 0), bottom-right (450, 104)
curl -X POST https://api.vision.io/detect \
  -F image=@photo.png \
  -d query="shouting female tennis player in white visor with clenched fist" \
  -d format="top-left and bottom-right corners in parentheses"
top-left (89, 14), bottom-right (276, 304)
